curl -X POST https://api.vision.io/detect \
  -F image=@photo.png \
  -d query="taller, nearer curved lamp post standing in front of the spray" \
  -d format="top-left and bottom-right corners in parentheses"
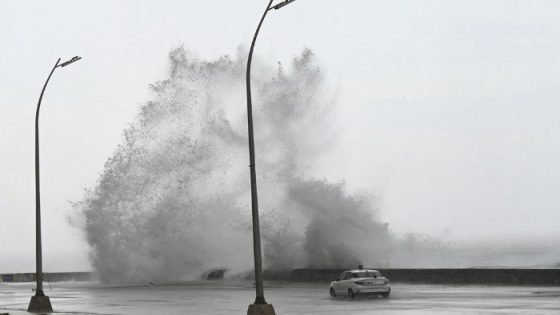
top-left (246, 0), bottom-right (295, 315)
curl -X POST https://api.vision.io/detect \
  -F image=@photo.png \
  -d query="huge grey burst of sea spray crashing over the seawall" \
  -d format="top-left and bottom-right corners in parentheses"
top-left (74, 47), bottom-right (444, 282)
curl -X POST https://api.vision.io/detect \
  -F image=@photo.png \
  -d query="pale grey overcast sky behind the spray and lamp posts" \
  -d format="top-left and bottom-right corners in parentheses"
top-left (0, 0), bottom-right (560, 272)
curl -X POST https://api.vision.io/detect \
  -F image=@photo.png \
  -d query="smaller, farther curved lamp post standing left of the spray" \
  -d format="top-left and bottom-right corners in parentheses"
top-left (27, 56), bottom-right (81, 313)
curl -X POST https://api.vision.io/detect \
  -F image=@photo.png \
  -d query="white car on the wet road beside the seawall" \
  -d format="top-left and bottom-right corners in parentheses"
top-left (329, 269), bottom-right (391, 298)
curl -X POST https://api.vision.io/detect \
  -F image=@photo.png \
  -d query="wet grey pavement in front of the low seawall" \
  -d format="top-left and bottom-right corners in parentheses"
top-left (0, 281), bottom-right (560, 315)
